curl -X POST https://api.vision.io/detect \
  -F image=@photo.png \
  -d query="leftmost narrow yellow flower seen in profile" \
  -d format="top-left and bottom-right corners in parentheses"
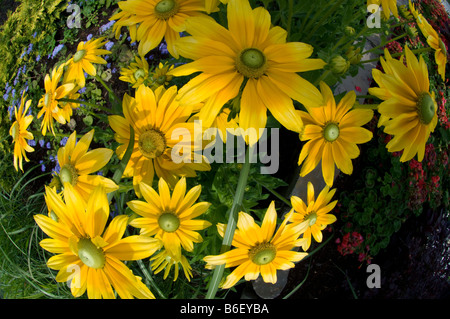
top-left (9, 91), bottom-right (34, 172)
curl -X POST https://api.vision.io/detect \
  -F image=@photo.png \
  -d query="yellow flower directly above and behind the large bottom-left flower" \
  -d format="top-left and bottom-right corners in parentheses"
top-left (57, 130), bottom-right (119, 200)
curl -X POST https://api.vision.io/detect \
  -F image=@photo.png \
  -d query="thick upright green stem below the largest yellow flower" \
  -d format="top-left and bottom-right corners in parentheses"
top-left (205, 146), bottom-right (254, 299)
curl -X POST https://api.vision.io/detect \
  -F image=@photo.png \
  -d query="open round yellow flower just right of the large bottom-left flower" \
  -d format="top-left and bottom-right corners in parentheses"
top-left (127, 178), bottom-right (211, 261)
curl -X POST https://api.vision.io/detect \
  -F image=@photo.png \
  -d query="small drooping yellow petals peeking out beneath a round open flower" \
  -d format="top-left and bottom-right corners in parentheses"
top-left (150, 250), bottom-right (192, 281)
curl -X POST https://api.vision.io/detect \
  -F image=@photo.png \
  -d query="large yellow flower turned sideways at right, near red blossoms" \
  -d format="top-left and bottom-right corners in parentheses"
top-left (369, 46), bottom-right (438, 162)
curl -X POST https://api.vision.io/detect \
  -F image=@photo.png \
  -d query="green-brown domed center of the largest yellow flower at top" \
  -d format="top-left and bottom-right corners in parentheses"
top-left (236, 48), bottom-right (267, 79)
